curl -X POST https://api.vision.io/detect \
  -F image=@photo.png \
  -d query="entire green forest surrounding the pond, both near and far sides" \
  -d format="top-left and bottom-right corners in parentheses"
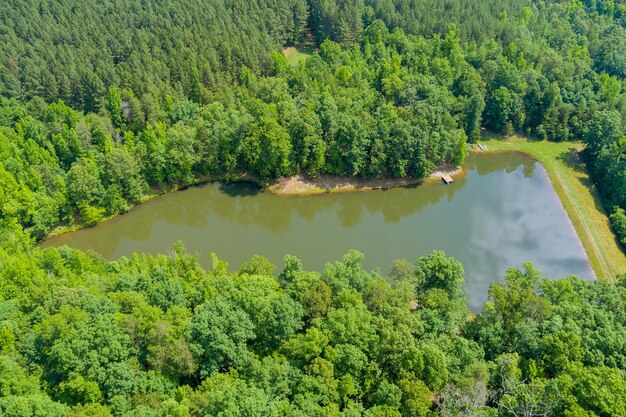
top-left (0, 0), bottom-right (626, 417)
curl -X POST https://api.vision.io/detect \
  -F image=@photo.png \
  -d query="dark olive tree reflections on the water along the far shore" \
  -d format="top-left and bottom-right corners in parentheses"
top-left (43, 154), bottom-right (535, 252)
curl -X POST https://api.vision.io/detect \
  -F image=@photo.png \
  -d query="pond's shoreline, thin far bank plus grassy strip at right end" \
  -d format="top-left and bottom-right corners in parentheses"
top-left (38, 133), bottom-right (626, 280)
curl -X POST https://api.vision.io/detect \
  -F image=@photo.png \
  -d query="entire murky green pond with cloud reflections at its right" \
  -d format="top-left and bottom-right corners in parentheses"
top-left (43, 154), bottom-right (594, 311)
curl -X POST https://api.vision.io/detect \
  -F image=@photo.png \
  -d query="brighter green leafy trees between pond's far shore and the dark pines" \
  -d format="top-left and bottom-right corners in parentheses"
top-left (0, 22), bottom-right (484, 238)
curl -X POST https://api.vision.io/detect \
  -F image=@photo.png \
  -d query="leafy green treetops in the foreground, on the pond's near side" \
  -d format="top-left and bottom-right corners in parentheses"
top-left (0, 225), bottom-right (626, 417)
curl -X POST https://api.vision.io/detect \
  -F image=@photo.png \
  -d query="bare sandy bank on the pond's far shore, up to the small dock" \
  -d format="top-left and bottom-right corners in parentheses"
top-left (267, 165), bottom-right (462, 196)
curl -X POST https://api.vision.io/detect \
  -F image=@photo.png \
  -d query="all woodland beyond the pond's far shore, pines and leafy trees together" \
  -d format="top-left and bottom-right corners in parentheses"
top-left (0, 0), bottom-right (626, 234)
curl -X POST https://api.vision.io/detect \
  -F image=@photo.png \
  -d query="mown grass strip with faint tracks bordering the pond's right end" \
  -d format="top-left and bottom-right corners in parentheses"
top-left (481, 134), bottom-right (626, 280)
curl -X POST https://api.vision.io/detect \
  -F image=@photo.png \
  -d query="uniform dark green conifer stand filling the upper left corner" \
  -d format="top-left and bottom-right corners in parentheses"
top-left (0, 0), bottom-right (307, 110)
